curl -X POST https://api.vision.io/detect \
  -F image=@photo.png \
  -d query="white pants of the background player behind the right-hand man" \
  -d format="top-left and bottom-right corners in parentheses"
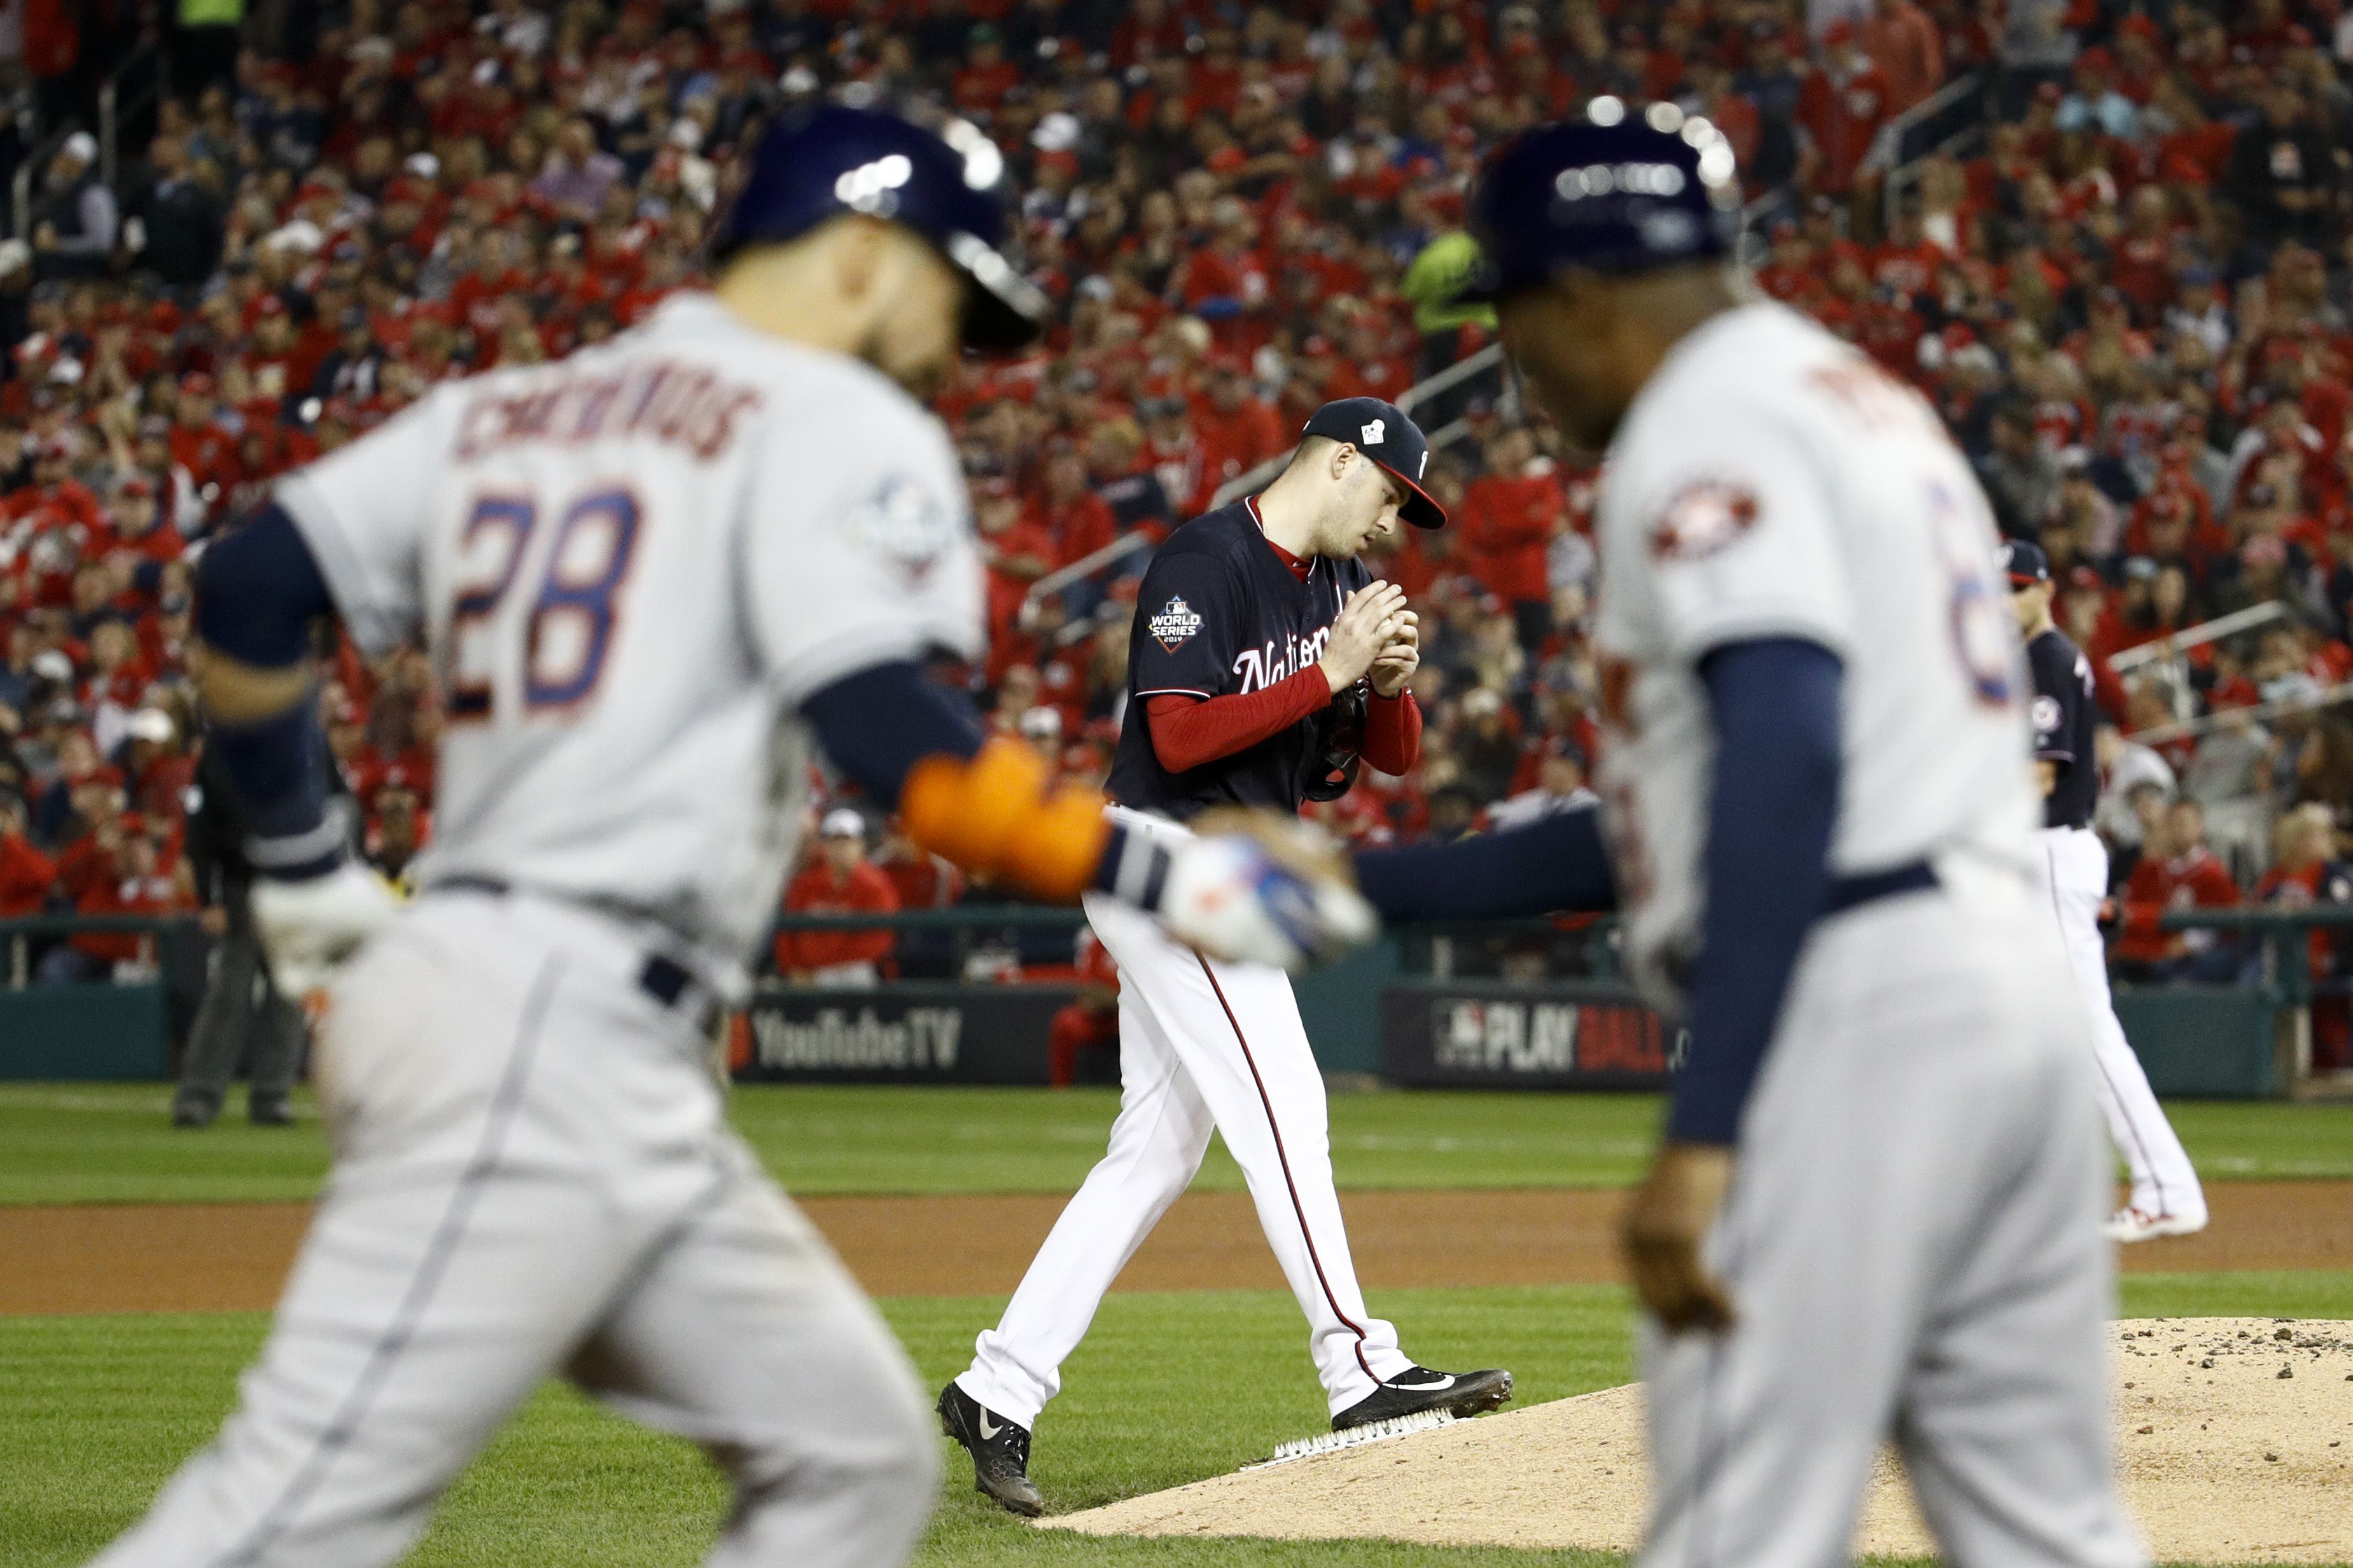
top-left (2035, 828), bottom-right (2205, 1220)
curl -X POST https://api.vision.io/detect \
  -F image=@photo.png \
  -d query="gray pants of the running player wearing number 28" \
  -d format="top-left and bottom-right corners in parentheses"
top-left (97, 893), bottom-right (939, 1568)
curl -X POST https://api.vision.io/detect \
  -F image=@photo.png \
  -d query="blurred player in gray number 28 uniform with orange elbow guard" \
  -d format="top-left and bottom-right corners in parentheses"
top-left (101, 108), bottom-right (1360, 1568)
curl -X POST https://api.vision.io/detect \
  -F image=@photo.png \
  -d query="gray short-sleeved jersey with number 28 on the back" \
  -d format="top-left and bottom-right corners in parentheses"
top-left (277, 294), bottom-right (984, 969)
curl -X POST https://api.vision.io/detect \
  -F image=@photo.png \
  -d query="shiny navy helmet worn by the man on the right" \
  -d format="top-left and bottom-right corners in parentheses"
top-left (1461, 97), bottom-right (1742, 301)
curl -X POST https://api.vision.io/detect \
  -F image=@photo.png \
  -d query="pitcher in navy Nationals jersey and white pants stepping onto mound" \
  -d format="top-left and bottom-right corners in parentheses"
top-left (939, 398), bottom-right (1511, 1514)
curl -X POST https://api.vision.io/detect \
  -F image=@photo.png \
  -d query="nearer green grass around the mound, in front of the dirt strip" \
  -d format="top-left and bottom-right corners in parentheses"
top-left (0, 1274), bottom-right (2353, 1568)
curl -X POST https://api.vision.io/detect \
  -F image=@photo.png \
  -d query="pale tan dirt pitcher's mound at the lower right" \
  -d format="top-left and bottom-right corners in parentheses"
top-left (1038, 1317), bottom-right (2353, 1564)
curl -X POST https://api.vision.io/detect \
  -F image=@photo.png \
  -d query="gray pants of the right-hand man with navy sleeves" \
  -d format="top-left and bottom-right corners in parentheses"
top-left (1642, 868), bottom-right (2146, 1568)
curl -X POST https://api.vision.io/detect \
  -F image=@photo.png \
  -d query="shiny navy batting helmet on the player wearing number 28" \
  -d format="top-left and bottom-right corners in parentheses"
top-left (711, 104), bottom-right (1047, 348)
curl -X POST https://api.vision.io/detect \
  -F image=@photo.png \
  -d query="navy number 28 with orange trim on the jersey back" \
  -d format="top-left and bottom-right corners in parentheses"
top-left (449, 487), bottom-right (640, 722)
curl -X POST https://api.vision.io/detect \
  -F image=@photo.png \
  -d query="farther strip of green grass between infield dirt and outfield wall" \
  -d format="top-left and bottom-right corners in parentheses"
top-left (0, 1084), bottom-right (2353, 1204)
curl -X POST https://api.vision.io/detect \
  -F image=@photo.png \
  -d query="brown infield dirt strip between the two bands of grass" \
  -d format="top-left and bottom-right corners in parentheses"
top-left (0, 1183), bottom-right (2353, 1314)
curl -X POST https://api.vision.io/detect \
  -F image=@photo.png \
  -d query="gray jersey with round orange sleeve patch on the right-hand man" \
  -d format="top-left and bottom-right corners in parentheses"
top-left (1595, 303), bottom-right (2035, 1004)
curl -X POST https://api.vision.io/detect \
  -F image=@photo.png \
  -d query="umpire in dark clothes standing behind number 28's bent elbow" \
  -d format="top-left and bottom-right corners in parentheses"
top-left (172, 740), bottom-right (339, 1126)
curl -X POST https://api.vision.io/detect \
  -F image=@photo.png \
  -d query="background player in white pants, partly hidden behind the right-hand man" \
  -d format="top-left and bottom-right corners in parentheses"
top-left (2002, 541), bottom-right (2207, 1241)
